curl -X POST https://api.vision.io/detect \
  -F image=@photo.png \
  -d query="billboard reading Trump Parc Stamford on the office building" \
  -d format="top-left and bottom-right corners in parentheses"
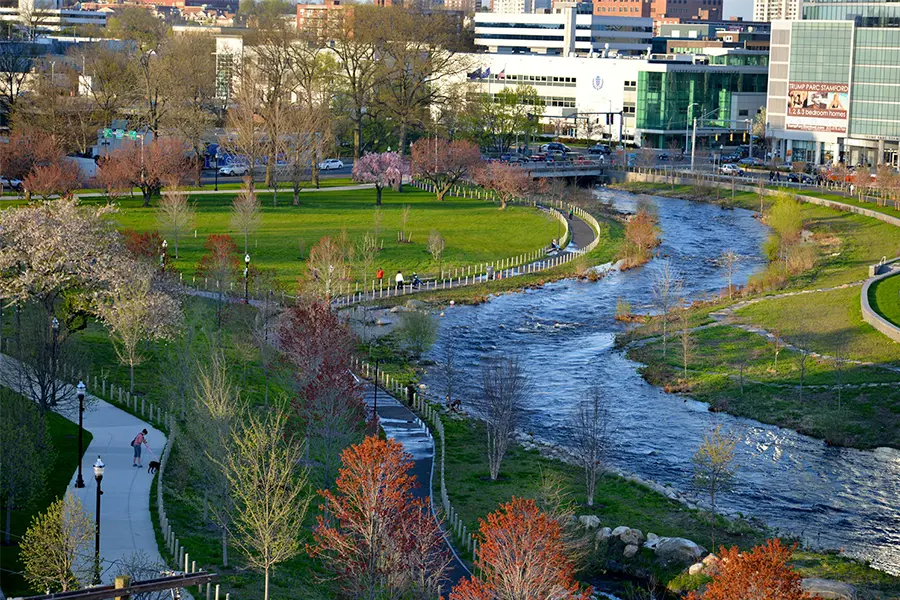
top-left (785, 81), bottom-right (850, 133)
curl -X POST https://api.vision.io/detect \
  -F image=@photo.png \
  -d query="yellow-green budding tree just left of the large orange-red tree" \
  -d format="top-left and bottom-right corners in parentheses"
top-left (218, 412), bottom-right (312, 600)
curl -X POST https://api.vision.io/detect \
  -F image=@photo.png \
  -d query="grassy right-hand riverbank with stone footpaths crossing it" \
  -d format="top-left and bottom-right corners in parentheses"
top-left (620, 183), bottom-right (900, 449)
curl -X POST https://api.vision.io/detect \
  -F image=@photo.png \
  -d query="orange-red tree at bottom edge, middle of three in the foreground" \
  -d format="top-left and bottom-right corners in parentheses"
top-left (450, 497), bottom-right (592, 600)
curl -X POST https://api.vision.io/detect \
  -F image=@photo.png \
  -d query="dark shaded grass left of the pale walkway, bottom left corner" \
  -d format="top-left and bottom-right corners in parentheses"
top-left (0, 406), bottom-right (93, 597)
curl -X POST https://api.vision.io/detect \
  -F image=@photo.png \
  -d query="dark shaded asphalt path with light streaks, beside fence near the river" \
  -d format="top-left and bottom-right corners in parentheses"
top-left (360, 380), bottom-right (471, 592)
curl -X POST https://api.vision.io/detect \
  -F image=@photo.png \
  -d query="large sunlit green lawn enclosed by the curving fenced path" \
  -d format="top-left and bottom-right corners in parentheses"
top-left (93, 187), bottom-right (557, 286)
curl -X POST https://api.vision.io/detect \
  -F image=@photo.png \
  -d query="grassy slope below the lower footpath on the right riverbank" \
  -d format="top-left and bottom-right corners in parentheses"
top-left (629, 325), bottom-right (900, 448)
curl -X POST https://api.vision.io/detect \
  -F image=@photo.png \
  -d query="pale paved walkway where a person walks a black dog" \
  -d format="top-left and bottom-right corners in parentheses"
top-left (0, 355), bottom-right (166, 583)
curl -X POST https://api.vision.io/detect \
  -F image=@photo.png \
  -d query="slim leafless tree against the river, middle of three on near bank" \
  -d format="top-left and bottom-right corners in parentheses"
top-left (569, 385), bottom-right (609, 506)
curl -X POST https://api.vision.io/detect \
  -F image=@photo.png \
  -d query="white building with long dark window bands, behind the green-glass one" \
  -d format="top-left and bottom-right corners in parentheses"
top-left (475, 9), bottom-right (653, 56)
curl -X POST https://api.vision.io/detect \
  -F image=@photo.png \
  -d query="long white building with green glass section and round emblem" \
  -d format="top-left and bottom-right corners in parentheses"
top-left (458, 48), bottom-right (767, 147)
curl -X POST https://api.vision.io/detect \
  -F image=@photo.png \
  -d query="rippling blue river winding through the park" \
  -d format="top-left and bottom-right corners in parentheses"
top-left (425, 190), bottom-right (900, 574)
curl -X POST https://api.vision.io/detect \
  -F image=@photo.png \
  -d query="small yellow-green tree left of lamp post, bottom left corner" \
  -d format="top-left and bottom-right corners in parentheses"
top-left (20, 492), bottom-right (94, 592)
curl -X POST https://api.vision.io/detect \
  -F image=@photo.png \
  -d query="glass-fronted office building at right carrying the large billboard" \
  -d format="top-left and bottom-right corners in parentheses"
top-left (767, 15), bottom-right (900, 166)
